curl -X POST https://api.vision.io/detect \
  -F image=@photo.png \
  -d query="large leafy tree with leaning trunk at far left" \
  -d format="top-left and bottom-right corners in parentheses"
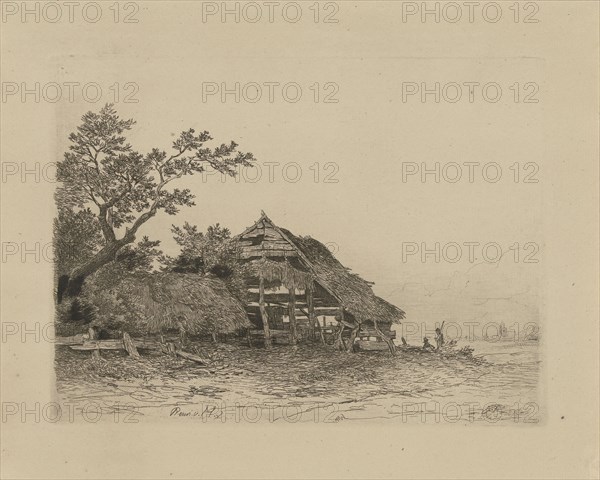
top-left (56, 104), bottom-right (254, 302)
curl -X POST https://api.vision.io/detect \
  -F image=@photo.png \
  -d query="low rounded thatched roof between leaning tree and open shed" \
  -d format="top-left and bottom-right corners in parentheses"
top-left (133, 273), bottom-right (252, 335)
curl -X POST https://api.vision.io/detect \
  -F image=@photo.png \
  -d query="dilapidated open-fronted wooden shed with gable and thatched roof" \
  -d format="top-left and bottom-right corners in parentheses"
top-left (235, 212), bottom-right (404, 352)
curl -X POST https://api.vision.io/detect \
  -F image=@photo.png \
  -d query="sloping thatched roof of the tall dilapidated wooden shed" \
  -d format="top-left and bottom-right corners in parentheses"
top-left (237, 212), bottom-right (404, 323)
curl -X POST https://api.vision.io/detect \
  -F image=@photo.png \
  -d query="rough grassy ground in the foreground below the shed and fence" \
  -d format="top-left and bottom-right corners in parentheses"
top-left (56, 341), bottom-right (542, 424)
